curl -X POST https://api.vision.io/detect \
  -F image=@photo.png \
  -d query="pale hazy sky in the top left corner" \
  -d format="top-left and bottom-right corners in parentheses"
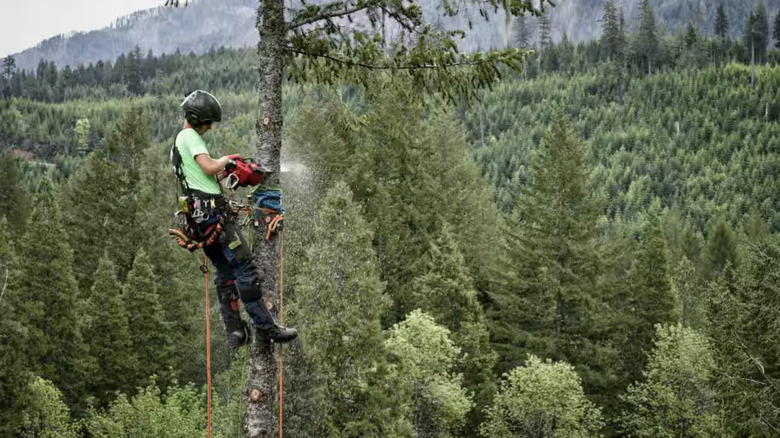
top-left (0, 0), bottom-right (165, 56)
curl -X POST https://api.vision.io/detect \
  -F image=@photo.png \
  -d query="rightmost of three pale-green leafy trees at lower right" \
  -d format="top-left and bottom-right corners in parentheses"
top-left (622, 324), bottom-right (725, 438)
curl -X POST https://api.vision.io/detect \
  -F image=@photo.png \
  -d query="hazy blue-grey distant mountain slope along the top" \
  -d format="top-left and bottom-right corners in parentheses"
top-left (14, 0), bottom-right (780, 70)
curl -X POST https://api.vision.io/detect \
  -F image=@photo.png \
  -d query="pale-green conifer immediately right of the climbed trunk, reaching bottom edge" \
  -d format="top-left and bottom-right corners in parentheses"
top-left (295, 183), bottom-right (408, 437)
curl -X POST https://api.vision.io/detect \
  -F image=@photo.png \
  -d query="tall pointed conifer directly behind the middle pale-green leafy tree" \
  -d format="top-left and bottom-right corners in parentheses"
top-left (506, 111), bottom-right (600, 372)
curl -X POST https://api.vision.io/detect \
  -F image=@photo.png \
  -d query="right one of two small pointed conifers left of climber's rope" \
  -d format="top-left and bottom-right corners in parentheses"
top-left (124, 250), bottom-right (173, 387)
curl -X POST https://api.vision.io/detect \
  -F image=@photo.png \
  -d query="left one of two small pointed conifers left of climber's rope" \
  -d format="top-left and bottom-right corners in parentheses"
top-left (83, 256), bottom-right (140, 407)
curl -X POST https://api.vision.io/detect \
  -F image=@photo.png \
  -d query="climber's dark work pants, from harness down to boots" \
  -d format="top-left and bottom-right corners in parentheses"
top-left (204, 216), bottom-right (275, 333)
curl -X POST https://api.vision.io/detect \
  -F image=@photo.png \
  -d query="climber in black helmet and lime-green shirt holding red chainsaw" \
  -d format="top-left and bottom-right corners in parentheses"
top-left (171, 90), bottom-right (298, 348)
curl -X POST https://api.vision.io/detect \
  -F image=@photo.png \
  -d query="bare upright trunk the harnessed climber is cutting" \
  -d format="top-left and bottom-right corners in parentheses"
top-left (243, 0), bottom-right (286, 438)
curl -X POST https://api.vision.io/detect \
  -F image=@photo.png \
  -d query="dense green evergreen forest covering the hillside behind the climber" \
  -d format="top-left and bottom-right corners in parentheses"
top-left (7, 0), bottom-right (780, 438)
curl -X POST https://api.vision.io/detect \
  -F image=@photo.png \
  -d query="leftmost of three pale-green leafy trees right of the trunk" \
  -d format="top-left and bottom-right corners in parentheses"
top-left (385, 310), bottom-right (472, 437)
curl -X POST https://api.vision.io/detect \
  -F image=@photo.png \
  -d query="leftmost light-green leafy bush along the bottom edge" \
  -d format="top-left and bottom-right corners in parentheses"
top-left (15, 377), bottom-right (78, 438)
